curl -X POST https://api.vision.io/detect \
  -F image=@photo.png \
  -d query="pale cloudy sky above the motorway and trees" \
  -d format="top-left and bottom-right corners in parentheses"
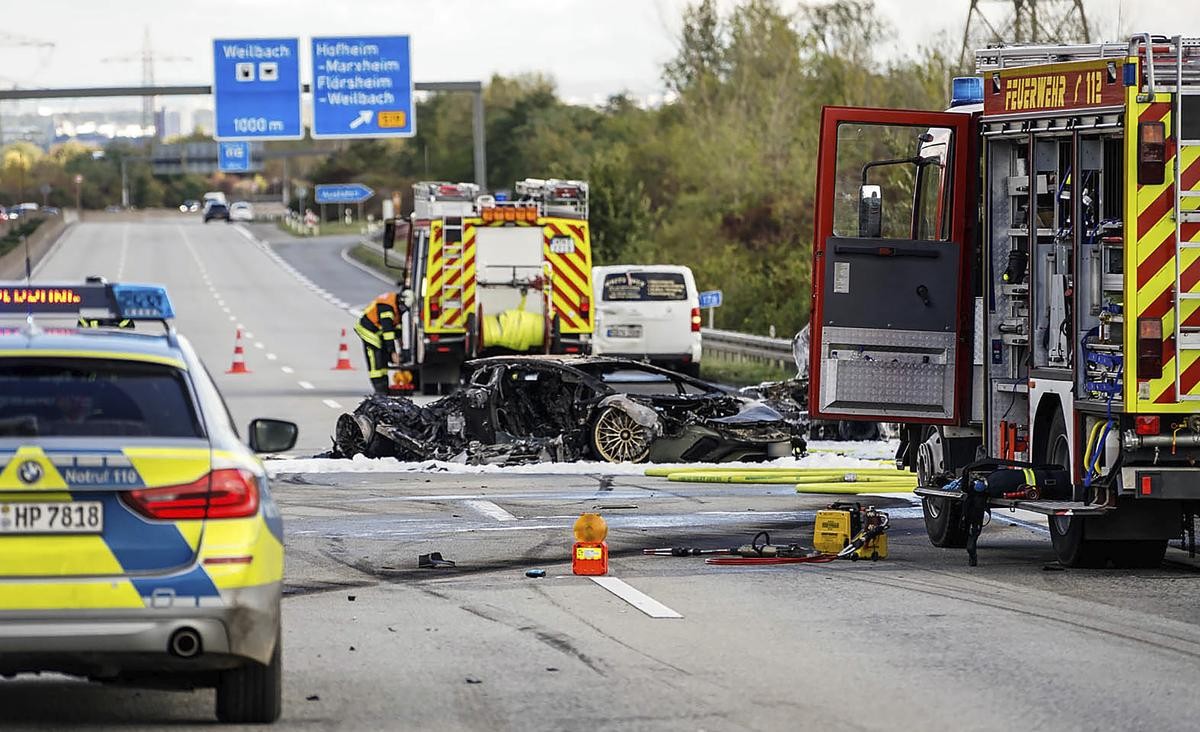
top-left (0, 0), bottom-right (1200, 110)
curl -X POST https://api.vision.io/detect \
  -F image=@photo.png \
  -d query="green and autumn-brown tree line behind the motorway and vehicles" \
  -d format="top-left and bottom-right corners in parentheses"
top-left (0, 0), bottom-right (955, 335)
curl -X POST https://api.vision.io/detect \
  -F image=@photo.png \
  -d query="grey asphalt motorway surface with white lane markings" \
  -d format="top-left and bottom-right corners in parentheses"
top-left (0, 214), bottom-right (1200, 731)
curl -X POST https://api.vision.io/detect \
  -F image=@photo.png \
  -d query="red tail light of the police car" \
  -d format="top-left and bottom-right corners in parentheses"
top-left (122, 468), bottom-right (258, 521)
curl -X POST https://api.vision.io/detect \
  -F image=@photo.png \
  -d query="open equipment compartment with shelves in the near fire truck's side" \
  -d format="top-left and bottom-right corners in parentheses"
top-left (985, 120), bottom-right (1124, 464)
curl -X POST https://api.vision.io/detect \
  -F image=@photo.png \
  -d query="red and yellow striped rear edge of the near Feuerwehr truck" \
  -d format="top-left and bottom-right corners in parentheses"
top-left (1124, 88), bottom-right (1200, 413)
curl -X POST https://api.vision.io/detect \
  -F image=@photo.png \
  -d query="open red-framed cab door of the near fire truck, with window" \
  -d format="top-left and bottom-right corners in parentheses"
top-left (809, 107), bottom-right (977, 425)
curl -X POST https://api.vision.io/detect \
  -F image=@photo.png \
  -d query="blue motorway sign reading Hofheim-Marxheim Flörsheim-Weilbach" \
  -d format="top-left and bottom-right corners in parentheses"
top-left (312, 36), bottom-right (416, 138)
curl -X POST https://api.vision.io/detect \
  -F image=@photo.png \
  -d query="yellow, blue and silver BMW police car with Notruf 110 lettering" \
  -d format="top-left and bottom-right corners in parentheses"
top-left (0, 280), bottom-right (296, 722)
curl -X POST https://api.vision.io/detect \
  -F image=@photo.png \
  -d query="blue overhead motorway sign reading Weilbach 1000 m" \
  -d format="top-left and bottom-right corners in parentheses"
top-left (212, 38), bottom-right (304, 140)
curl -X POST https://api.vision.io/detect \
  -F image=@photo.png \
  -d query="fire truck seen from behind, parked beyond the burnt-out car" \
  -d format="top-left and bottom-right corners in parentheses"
top-left (384, 178), bottom-right (594, 394)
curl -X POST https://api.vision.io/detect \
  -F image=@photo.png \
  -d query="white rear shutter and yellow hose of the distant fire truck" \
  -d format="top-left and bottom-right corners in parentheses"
top-left (475, 226), bottom-right (546, 352)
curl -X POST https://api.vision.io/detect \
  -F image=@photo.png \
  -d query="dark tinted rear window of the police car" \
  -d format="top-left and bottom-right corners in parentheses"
top-left (0, 359), bottom-right (204, 438)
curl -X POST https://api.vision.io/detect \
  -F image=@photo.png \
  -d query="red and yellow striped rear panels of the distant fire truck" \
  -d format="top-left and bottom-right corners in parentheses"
top-left (425, 213), bottom-right (593, 334)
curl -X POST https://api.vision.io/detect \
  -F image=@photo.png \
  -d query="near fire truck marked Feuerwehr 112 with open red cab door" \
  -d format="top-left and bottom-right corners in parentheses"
top-left (810, 35), bottom-right (1200, 566)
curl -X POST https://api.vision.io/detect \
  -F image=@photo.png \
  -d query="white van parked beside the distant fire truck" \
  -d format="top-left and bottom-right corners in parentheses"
top-left (592, 264), bottom-right (701, 376)
